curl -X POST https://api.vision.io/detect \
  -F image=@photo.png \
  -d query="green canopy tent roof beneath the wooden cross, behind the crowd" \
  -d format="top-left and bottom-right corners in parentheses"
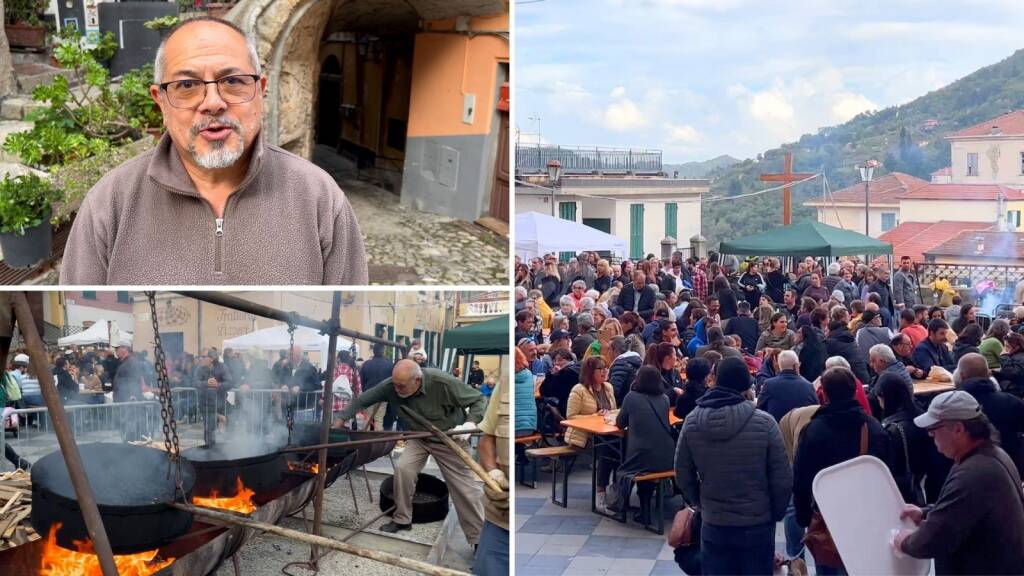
top-left (719, 220), bottom-right (893, 258)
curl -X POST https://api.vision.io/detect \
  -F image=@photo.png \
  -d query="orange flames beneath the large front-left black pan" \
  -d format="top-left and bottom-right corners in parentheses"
top-left (39, 523), bottom-right (174, 576)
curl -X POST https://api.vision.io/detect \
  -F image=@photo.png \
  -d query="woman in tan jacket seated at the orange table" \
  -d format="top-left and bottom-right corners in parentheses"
top-left (569, 356), bottom-right (614, 513)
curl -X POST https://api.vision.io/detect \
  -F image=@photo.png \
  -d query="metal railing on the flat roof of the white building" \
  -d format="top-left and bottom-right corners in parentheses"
top-left (515, 145), bottom-right (662, 174)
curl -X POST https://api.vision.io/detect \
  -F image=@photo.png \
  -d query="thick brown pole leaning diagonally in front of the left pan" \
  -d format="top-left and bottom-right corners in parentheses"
top-left (11, 292), bottom-right (118, 576)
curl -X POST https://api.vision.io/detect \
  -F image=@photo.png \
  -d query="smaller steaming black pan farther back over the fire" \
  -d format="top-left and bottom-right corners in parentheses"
top-left (181, 443), bottom-right (287, 498)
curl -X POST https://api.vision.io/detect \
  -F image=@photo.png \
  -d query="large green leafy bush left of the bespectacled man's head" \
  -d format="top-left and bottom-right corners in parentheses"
top-left (3, 32), bottom-right (162, 168)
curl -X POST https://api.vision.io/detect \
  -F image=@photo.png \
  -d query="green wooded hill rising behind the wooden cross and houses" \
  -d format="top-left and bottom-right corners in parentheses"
top-left (702, 46), bottom-right (1024, 248)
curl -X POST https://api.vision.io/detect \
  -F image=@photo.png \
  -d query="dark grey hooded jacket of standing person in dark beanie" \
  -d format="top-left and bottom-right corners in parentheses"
top-left (676, 387), bottom-right (793, 527)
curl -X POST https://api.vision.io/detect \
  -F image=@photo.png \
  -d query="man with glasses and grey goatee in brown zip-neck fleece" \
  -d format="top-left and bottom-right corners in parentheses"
top-left (60, 16), bottom-right (368, 285)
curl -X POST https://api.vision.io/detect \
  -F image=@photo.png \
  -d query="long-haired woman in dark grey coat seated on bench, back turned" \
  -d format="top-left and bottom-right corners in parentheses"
top-left (615, 366), bottom-right (676, 525)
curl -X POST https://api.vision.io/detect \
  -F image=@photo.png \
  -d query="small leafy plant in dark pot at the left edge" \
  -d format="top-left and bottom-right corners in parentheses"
top-left (0, 172), bottom-right (60, 268)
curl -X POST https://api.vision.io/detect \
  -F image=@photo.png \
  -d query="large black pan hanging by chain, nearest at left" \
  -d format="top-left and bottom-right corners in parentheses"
top-left (32, 443), bottom-right (196, 554)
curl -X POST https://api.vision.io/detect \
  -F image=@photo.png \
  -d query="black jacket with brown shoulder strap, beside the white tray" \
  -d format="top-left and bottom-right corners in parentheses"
top-left (793, 399), bottom-right (889, 526)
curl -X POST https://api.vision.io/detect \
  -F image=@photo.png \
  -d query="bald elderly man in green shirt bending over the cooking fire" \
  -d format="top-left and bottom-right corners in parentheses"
top-left (338, 360), bottom-right (487, 545)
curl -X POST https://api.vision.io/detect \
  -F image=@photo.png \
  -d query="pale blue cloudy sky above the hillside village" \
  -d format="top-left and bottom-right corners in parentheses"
top-left (513, 0), bottom-right (1024, 162)
